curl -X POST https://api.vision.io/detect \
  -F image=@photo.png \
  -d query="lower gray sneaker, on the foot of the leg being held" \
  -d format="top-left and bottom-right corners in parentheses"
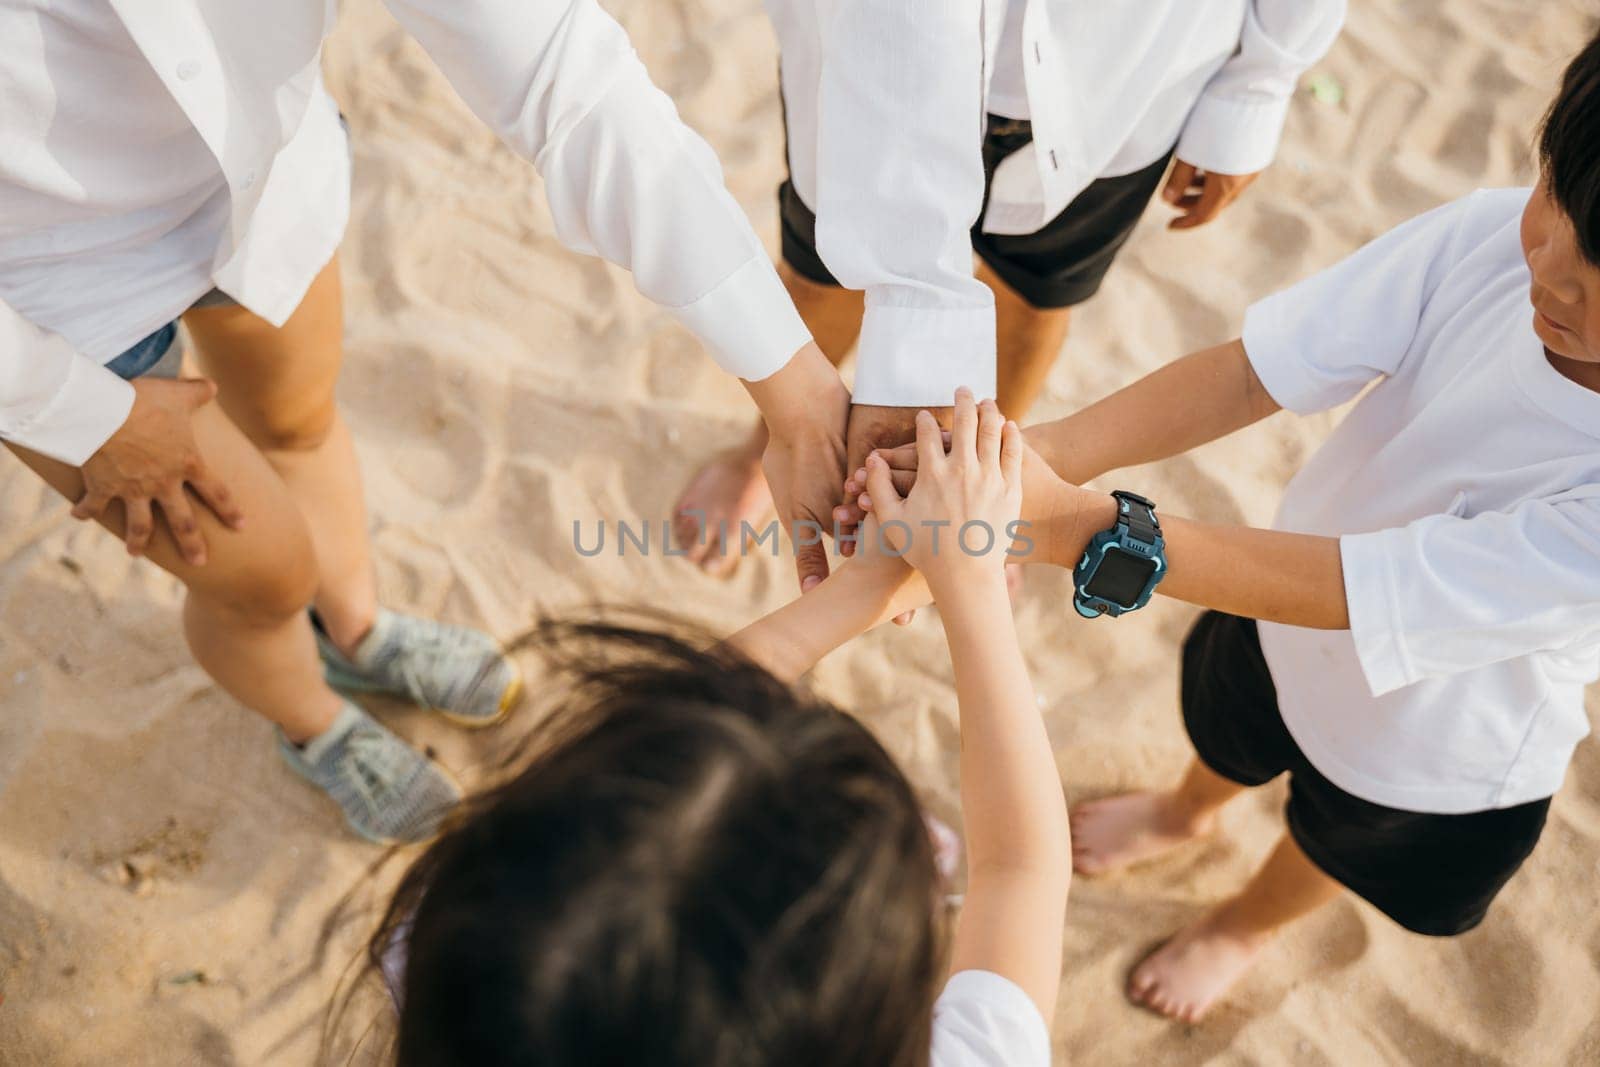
top-left (278, 702), bottom-right (461, 845)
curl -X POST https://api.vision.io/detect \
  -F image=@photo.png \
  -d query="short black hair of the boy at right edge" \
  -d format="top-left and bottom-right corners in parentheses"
top-left (1539, 24), bottom-right (1600, 266)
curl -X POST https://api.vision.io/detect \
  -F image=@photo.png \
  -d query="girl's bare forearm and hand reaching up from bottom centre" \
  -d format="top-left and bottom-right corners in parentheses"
top-left (867, 390), bottom-right (1072, 1019)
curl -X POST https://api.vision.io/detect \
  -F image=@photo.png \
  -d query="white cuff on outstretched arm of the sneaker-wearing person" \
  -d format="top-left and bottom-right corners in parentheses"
top-left (669, 253), bottom-right (811, 382)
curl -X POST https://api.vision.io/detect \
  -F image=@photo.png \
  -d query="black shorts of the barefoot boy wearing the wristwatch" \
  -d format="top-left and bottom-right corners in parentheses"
top-left (1182, 611), bottom-right (1550, 936)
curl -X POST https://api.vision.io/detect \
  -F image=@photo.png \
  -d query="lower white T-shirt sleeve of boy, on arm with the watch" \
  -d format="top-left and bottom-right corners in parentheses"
top-left (1339, 486), bottom-right (1600, 696)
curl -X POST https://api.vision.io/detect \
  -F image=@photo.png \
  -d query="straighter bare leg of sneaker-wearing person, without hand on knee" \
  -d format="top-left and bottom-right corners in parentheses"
top-left (184, 258), bottom-right (378, 653)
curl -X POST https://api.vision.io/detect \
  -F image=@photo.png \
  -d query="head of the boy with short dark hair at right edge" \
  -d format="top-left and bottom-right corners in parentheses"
top-left (1522, 24), bottom-right (1600, 363)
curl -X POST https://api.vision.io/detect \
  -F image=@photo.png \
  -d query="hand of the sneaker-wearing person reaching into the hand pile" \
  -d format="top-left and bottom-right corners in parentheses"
top-left (746, 344), bottom-right (850, 592)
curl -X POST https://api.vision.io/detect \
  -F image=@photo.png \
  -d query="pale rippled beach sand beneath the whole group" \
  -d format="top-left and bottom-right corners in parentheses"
top-left (0, 0), bottom-right (1600, 1067)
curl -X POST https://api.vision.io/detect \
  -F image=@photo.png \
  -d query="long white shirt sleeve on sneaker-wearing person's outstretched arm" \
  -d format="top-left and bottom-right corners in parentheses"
top-left (387, 0), bottom-right (811, 381)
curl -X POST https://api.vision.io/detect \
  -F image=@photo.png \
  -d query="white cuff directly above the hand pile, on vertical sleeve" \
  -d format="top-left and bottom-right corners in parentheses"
top-left (851, 299), bottom-right (995, 408)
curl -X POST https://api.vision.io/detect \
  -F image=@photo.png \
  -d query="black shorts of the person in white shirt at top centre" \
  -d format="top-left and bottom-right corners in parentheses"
top-left (778, 115), bottom-right (1171, 307)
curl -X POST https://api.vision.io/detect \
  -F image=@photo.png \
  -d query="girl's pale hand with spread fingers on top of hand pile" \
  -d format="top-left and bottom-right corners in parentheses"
top-left (864, 389), bottom-right (1024, 593)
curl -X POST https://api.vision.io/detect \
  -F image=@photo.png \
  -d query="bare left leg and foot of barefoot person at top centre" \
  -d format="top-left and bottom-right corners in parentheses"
top-left (672, 262), bottom-right (864, 576)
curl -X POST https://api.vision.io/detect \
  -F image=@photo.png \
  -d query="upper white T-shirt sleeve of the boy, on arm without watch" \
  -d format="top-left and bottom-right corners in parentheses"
top-left (1242, 198), bottom-right (1470, 414)
